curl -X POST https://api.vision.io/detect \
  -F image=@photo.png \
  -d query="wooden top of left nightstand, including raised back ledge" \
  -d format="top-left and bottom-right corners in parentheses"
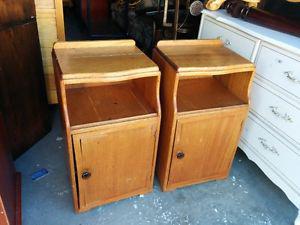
top-left (53, 40), bottom-right (159, 79)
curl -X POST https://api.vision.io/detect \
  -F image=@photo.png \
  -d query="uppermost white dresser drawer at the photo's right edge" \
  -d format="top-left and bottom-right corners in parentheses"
top-left (256, 45), bottom-right (300, 98)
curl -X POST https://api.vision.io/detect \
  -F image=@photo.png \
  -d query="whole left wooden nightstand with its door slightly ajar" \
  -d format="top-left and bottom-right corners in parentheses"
top-left (53, 40), bottom-right (160, 212)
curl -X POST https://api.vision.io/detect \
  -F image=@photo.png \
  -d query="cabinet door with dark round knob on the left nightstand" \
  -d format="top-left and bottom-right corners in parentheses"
top-left (73, 118), bottom-right (157, 209)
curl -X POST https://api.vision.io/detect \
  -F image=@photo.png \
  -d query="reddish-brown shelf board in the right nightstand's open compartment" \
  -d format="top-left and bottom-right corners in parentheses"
top-left (177, 77), bottom-right (246, 113)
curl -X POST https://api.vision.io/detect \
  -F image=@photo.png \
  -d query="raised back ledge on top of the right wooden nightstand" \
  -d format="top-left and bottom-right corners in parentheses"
top-left (156, 39), bottom-right (223, 48)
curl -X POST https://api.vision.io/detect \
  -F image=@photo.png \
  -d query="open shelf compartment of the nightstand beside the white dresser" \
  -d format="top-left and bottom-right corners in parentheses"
top-left (177, 73), bottom-right (251, 114)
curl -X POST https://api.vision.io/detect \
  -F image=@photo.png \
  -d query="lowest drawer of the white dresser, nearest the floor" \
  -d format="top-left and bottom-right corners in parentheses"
top-left (242, 117), bottom-right (300, 190)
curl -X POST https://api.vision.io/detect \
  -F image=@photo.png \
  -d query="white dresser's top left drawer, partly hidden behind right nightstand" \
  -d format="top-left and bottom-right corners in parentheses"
top-left (200, 17), bottom-right (256, 60)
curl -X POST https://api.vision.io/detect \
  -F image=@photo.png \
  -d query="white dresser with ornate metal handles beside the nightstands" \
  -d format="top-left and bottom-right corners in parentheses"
top-left (198, 10), bottom-right (300, 225)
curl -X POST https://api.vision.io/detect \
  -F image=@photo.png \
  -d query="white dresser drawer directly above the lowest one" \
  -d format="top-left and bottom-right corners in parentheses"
top-left (250, 82), bottom-right (300, 144)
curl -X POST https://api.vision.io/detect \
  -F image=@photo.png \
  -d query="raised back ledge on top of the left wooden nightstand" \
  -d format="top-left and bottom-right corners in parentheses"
top-left (53, 39), bottom-right (135, 49)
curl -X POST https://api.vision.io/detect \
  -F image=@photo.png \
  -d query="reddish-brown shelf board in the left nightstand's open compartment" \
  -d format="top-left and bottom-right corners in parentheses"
top-left (66, 83), bottom-right (155, 129)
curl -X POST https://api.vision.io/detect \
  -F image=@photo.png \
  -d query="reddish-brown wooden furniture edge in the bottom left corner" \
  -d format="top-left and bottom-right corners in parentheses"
top-left (0, 112), bottom-right (22, 225)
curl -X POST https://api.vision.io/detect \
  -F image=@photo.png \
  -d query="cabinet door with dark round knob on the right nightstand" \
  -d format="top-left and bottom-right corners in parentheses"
top-left (168, 107), bottom-right (247, 188)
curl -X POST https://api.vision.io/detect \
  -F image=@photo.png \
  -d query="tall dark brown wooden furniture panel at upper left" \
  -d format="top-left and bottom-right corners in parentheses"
top-left (0, 0), bottom-right (50, 157)
